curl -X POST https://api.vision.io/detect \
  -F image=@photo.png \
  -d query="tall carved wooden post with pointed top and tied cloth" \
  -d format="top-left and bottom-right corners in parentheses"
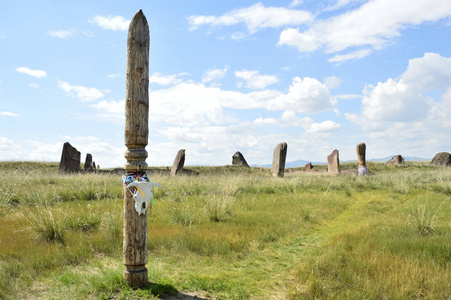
top-left (123, 10), bottom-right (150, 287)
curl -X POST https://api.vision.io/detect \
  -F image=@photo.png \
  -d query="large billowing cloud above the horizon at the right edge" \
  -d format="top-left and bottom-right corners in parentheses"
top-left (345, 53), bottom-right (451, 158)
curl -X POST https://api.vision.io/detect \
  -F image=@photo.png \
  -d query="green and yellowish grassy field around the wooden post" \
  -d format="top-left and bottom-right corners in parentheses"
top-left (0, 162), bottom-right (451, 299)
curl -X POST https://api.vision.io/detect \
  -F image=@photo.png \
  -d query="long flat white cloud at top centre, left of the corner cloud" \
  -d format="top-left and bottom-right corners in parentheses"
top-left (188, 3), bottom-right (313, 33)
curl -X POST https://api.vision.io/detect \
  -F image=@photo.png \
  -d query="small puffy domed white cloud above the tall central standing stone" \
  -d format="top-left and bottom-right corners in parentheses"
top-left (269, 77), bottom-right (336, 113)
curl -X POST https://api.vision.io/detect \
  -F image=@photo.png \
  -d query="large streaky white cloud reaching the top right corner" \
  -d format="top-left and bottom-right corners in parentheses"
top-left (278, 0), bottom-right (451, 59)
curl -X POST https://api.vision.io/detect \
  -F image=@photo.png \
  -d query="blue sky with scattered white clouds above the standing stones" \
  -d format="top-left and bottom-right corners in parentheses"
top-left (0, 0), bottom-right (451, 168)
